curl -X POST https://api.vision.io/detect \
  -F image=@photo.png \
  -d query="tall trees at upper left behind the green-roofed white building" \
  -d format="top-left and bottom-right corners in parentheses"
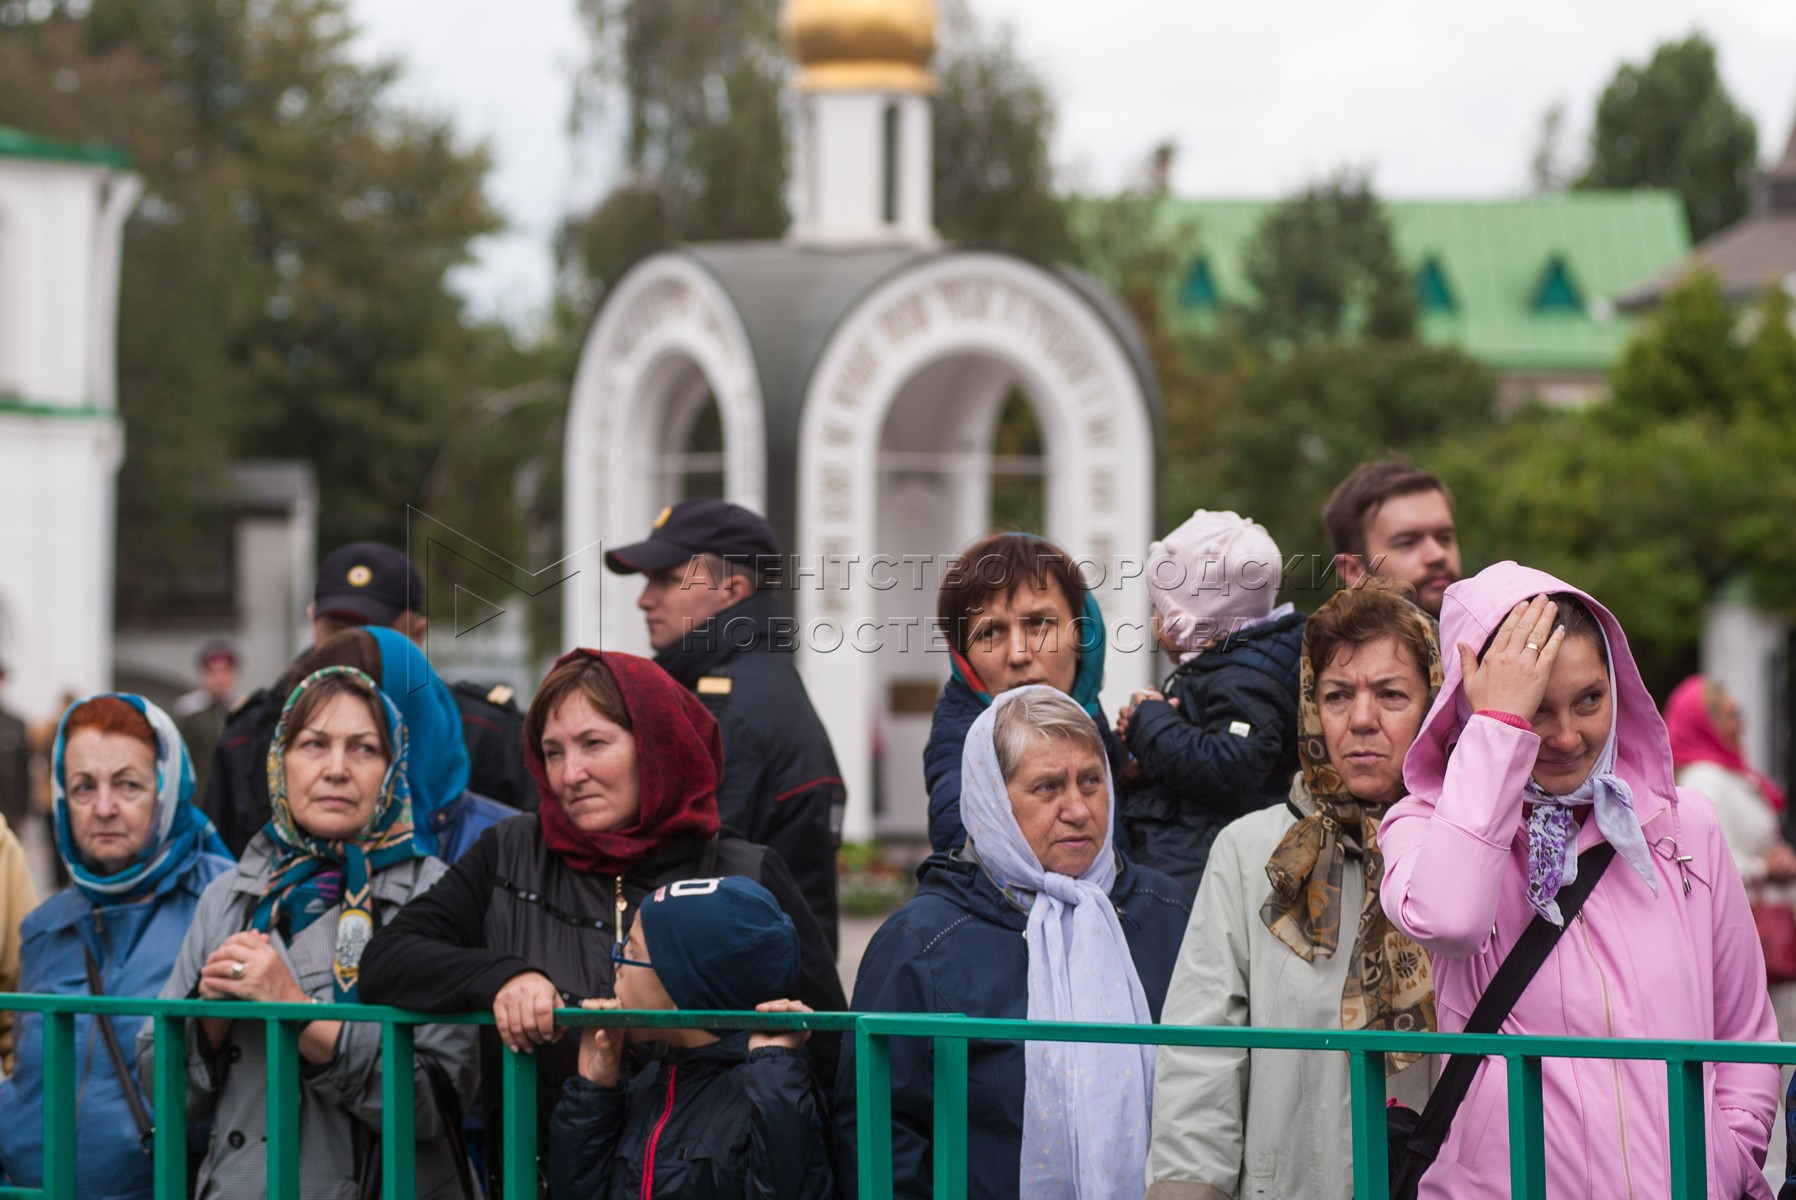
top-left (0, 0), bottom-right (497, 609)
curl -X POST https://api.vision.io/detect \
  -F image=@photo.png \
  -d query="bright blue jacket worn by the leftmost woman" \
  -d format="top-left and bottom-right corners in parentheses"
top-left (0, 853), bottom-right (232, 1200)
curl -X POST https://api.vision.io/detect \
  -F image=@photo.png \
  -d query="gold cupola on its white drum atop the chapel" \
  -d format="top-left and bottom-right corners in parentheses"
top-left (779, 0), bottom-right (938, 246)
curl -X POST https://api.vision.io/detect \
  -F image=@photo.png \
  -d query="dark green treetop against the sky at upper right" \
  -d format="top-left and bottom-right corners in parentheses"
top-left (1579, 32), bottom-right (1758, 241)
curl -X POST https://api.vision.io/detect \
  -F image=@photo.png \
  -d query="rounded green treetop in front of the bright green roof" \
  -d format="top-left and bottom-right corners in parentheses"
top-left (1239, 171), bottom-right (1415, 349)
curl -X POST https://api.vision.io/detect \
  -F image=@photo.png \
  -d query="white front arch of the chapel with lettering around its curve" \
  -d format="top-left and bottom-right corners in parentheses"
top-left (796, 253), bottom-right (1155, 839)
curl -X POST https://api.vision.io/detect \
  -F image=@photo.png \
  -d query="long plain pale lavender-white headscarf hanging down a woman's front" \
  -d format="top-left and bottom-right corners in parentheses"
top-left (961, 686), bottom-right (1155, 1200)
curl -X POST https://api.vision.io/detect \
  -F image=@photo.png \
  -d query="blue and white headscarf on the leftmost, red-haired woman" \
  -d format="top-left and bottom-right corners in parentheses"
top-left (50, 692), bottom-right (232, 905)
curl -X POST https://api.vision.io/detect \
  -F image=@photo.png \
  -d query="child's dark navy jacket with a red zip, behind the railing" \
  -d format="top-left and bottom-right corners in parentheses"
top-left (548, 1033), bottom-right (833, 1200)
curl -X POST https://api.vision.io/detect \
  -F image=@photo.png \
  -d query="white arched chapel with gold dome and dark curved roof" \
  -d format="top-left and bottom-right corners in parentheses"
top-left (564, 0), bottom-right (1160, 839)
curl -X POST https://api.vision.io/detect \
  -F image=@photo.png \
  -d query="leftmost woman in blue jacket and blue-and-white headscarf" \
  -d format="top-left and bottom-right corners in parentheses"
top-left (0, 692), bottom-right (232, 1200)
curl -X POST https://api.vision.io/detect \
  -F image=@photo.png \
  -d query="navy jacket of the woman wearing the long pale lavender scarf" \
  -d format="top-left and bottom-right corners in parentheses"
top-left (835, 853), bottom-right (1191, 1200)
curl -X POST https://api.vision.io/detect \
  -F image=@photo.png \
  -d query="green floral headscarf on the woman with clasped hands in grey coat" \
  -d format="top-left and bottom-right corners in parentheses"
top-left (250, 666), bottom-right (429, 1004)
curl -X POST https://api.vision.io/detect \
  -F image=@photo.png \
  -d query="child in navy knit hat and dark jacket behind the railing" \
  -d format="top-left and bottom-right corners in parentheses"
top-left (548, 877), bottom-right (833, 1200)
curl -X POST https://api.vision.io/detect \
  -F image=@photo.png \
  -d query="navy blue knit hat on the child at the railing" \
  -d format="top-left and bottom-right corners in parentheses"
top-left (636, 875), bottom-right (797, 1011)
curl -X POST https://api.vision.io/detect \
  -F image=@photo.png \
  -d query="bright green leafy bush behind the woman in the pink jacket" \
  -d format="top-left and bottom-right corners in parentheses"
top-left (1430, 275), bottom-right (1796, 695)
